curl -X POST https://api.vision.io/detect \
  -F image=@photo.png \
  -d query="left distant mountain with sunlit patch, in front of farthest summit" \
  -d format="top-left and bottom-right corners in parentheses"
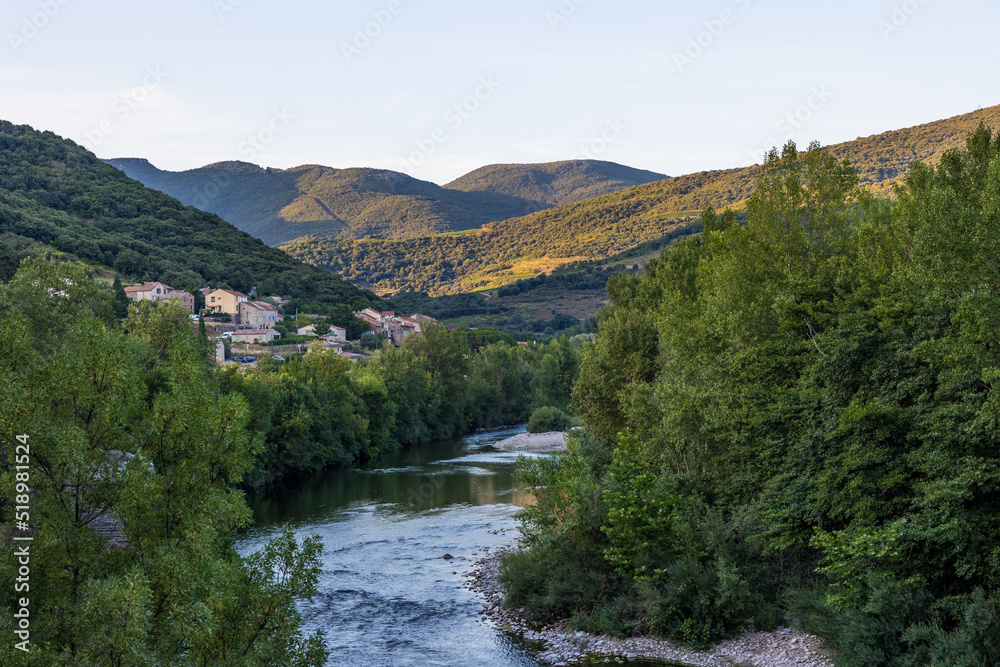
top-left (108, 158), bottom-right (548, 245)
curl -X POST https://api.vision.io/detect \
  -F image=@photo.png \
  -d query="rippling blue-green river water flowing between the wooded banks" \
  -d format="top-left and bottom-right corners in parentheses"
top-left (237, 428), bottom-right (672, 667)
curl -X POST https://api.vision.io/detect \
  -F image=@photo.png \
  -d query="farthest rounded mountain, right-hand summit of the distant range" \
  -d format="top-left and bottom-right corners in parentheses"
top-left (444, 160), bottom-right (668, 206)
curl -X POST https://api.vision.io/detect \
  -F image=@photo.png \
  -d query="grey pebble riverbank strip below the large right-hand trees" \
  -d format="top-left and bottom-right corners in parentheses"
top-left (466, 548), bottom-right (833, 667)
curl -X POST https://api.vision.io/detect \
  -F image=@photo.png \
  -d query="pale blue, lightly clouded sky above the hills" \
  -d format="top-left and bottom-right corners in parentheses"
top-left (0, 0), bottom-right (1000, 185)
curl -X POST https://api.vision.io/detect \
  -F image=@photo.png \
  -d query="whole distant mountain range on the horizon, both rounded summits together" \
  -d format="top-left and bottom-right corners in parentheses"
top-left (101, 158), bottom-right (664, 245)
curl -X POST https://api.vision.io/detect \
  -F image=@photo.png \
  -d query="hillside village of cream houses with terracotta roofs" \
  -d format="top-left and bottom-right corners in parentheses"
top-left (124, 282), bottom-right (434, 365)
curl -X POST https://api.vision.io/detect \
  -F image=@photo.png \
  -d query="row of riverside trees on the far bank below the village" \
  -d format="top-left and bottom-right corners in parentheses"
top-left (220, 326), bottom-right (579, 488)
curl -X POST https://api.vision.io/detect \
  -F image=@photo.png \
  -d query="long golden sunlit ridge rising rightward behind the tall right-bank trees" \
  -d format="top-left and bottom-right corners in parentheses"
top-left (283, 106), bottom-right (1000, 295)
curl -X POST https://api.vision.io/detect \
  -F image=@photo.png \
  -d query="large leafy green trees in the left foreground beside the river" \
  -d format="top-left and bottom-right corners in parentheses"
top-left (0, 259), bottom-right (326, 667)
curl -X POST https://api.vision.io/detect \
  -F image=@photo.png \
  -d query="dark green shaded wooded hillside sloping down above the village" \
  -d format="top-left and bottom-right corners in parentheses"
top-left (0, 121), bottom-right (373, 304)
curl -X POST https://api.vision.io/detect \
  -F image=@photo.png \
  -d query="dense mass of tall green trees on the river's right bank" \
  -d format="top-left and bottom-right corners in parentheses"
top-left (502, 127), bottom-right (1000, 667)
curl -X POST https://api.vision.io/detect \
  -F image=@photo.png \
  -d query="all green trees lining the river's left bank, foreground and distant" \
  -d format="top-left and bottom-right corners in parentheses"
top-left (0, 258), bottom-right (580, 667)
